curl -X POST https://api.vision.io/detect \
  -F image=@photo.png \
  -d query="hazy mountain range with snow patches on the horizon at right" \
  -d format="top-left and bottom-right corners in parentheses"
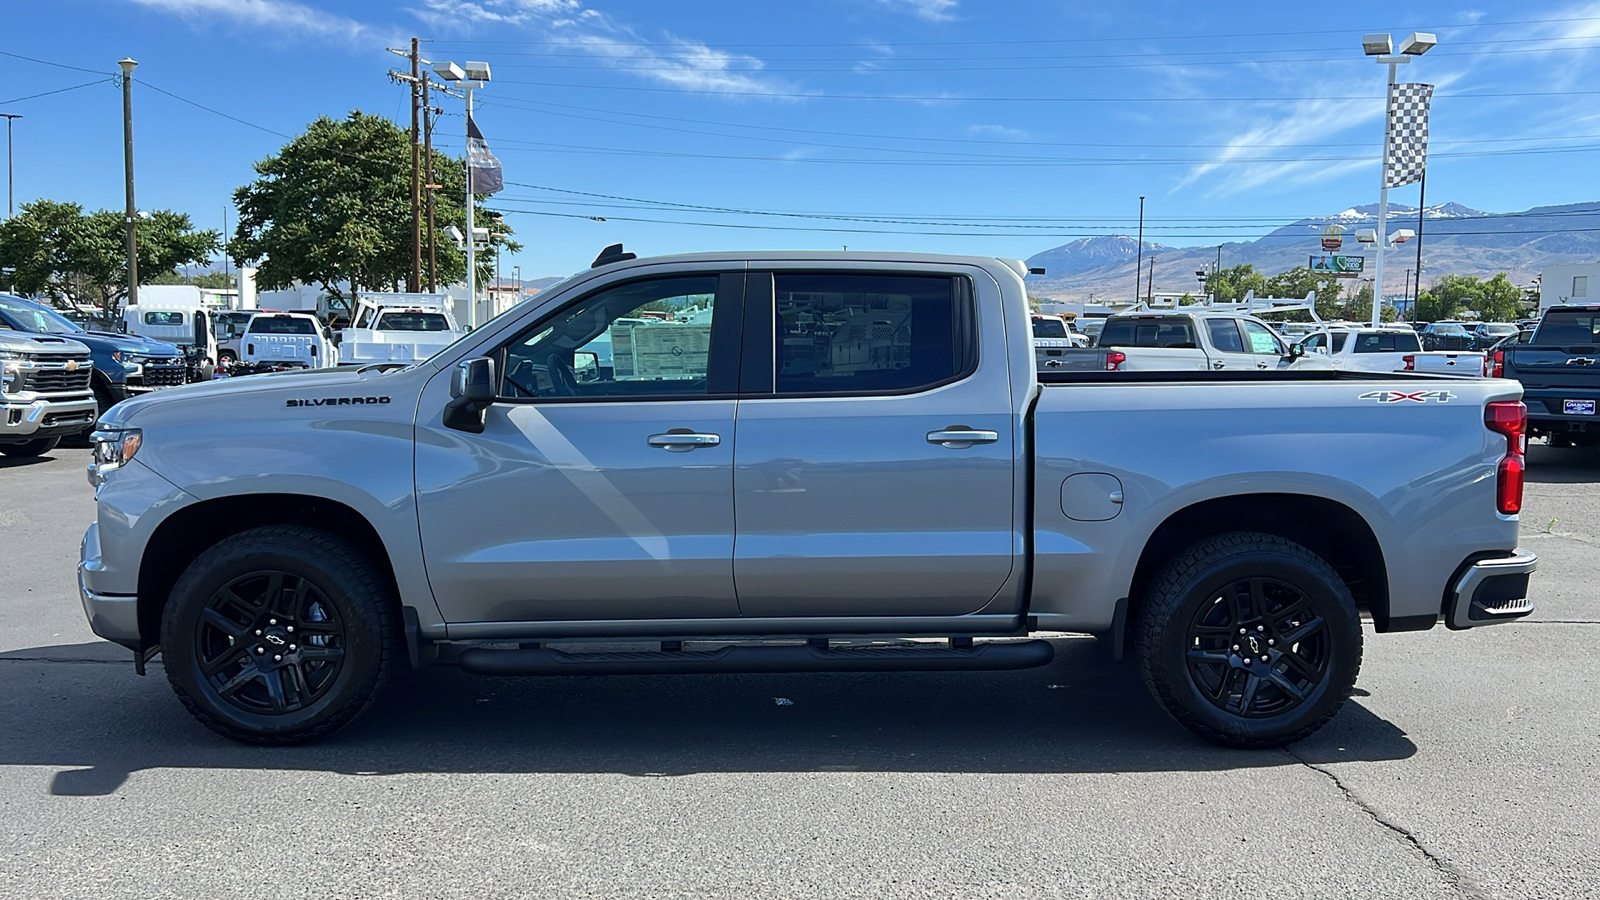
top-left (1027, 202), bottom-right (1600, 299)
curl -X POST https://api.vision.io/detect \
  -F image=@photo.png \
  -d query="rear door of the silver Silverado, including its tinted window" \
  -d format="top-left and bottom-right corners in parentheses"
top-left (733, 269), bottom-right (1021, 617)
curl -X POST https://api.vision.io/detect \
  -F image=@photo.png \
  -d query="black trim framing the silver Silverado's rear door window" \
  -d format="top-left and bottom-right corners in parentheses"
top-left (739, 267), bottom-right (985, 400)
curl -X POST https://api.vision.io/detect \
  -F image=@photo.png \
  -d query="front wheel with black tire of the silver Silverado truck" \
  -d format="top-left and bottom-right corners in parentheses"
top-left (162, 525), bottom-right (395, 745)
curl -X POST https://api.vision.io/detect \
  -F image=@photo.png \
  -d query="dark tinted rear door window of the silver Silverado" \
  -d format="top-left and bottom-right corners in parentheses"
top-left (773, 272), bottom-right (976, 394)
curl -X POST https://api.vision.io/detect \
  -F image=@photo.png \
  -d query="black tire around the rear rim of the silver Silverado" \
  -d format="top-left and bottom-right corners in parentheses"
top-left (1152, 549), bottom-right (1362, 743)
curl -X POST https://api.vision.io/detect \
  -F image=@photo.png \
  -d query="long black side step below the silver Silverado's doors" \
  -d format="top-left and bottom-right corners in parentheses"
top-left (461, 641), bottom-right (1056, 676)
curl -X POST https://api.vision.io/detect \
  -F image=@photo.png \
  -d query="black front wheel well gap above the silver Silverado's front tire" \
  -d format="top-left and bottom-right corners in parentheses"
top-left (138, 493), bottom-right (400, 647)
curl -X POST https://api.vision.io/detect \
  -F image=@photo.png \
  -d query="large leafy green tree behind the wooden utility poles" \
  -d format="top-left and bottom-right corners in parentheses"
top-left (227, 110), bottom-right (522, 317)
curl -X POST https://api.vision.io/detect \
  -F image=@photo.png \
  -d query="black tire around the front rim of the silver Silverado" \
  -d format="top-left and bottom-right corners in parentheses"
top-left (162, 532), bottom-right (384, 738)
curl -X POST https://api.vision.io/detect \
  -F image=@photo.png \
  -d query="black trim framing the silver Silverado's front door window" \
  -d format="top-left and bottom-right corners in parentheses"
top-left (483, 269), bottom-right (746, 405)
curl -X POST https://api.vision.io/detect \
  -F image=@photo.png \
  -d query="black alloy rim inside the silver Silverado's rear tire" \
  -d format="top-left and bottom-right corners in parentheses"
top-left (1189, 578), bottom-right (1330, 719)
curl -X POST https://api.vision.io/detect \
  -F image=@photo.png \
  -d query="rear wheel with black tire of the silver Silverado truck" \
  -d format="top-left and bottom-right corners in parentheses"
top-left (1139, 532), bottom-right (1362, 748)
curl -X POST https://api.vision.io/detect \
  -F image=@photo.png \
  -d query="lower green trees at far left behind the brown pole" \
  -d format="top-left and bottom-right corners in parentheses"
top-left (0, 200), bottom-right (221, 317)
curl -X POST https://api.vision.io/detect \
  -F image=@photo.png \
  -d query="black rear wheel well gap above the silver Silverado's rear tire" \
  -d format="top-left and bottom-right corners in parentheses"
top-left (1123, 493), bottom-right (1389, 650)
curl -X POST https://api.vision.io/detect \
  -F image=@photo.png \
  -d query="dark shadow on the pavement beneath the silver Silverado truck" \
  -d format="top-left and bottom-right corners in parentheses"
top-left (0, 639), bottom-right (1416, 796)
